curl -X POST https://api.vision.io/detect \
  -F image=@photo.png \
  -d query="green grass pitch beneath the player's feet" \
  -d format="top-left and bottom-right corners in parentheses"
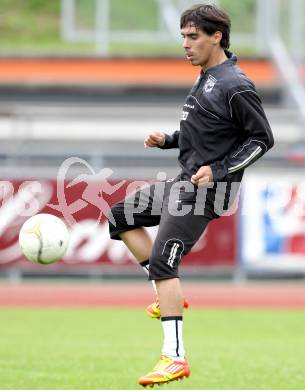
top-left (0, 308), bottom-right (305, 390)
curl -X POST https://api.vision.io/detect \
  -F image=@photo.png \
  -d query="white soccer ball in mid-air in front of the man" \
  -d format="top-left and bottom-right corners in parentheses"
top-left (19, 214), bottom-right (69, 264)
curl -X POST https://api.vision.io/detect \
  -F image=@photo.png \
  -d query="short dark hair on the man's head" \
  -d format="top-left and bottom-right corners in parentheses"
top-left (180, 4), bottom-right (231, 49)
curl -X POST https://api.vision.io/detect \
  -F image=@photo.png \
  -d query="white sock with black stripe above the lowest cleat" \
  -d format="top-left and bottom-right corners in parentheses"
top-left (161, 316), bottom-right (185, 360)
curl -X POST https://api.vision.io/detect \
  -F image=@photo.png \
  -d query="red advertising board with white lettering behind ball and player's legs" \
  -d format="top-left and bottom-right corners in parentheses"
top-left (0, 175), bottom-right (237, 272)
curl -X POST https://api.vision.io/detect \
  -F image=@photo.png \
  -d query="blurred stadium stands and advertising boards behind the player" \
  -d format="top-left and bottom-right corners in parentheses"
top-left (0, 0), bottom-right (305, 280)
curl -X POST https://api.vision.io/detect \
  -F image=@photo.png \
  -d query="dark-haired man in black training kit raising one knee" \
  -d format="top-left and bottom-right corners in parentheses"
top-left (110, 4), bottom-right (273, 386)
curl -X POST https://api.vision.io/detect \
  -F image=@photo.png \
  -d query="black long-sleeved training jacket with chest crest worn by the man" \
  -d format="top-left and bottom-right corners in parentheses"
top-left (161, 51), bottom-right (274, 182)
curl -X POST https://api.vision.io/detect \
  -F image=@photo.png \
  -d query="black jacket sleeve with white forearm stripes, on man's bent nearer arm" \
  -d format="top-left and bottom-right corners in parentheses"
top-left (211, 89), bottom-right (274, 181)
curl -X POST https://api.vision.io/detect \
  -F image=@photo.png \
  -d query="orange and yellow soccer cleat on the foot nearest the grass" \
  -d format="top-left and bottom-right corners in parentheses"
top-left (139, 356), bottom-right (191, 387)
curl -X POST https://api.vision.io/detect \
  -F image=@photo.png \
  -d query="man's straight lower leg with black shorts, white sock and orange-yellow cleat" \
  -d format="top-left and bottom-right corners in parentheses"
top-left (139, 184), bottom-right (216, 386)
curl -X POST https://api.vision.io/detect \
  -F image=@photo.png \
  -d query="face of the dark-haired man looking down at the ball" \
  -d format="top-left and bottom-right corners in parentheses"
top-left (181, 23), bottom-right (217, 66)
